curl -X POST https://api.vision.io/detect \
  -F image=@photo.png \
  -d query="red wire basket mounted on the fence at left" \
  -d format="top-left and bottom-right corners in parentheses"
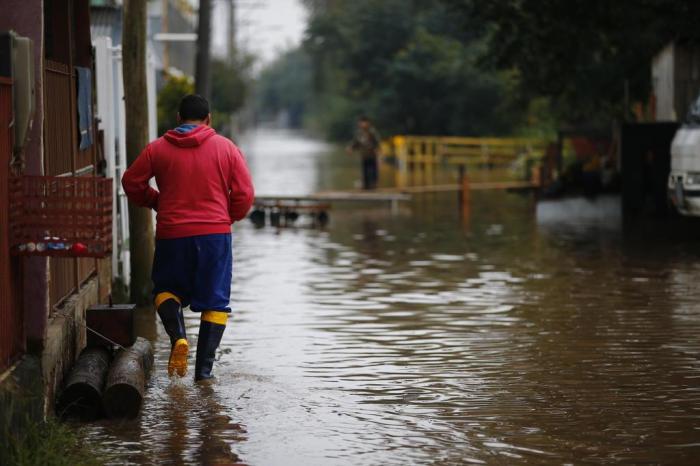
top-left (10, 176), bottom-right (112, 257)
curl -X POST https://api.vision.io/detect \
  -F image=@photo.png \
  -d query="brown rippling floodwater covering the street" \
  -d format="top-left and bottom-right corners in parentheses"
top-left (83, 131), bottom-right (700, 466)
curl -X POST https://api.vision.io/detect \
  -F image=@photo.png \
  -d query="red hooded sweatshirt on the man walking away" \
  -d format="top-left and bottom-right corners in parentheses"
top-left (122, 125), bottom-right (254, 239)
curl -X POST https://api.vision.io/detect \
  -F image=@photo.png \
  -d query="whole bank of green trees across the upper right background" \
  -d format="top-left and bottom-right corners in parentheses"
top-left (292, 0), bottom-right (700, 138)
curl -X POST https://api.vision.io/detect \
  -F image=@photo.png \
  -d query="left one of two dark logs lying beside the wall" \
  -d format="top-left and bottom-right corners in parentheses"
top-left (56, 347), bottom-right (111, 421)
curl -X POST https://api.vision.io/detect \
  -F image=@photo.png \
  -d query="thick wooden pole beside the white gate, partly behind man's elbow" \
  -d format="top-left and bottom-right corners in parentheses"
top-left (122, 0), bottom-right (154, 305)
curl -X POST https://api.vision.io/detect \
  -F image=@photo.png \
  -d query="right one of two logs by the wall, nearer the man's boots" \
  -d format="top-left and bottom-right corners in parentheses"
top-left (102, 337), bottom-right (153, 419)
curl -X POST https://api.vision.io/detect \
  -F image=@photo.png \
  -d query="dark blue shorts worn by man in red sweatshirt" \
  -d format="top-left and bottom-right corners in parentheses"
top-left (151, 233), bottom-right (233, 312)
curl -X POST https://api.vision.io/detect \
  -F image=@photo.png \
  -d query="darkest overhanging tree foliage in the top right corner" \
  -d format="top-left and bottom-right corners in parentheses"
top-left (441, 0), bottom-right (700, 123)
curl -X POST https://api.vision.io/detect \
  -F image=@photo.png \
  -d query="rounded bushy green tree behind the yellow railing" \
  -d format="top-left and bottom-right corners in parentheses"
top-left (369, 27), bottom-right (511, 135)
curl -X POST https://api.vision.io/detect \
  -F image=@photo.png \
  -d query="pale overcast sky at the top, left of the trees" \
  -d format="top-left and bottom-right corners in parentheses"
top-left (212, 0), bottom-right (306, 69)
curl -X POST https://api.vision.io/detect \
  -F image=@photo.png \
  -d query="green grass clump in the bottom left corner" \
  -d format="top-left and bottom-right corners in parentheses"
top-left (0, 418), bottom-right (107, 466)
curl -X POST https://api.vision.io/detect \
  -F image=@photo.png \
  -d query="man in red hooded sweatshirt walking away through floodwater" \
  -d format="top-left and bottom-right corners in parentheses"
top-left (122, 95), bottom-right (254, 380)
